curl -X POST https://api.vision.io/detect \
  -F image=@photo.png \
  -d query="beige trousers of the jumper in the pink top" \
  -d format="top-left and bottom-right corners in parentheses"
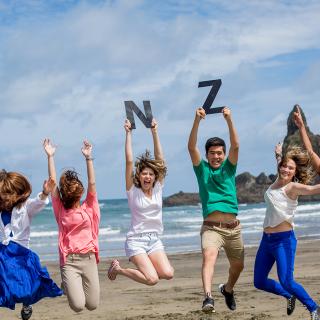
top-left (60, 252), bottom-right (100, 312)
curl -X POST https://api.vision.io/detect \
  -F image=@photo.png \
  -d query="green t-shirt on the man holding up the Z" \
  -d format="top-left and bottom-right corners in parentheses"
top-left (193, 158), bottom-right (238, 218)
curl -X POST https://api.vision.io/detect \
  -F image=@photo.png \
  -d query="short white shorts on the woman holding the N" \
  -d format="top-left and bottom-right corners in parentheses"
top-left (125, 232), bottom-right (164, 259)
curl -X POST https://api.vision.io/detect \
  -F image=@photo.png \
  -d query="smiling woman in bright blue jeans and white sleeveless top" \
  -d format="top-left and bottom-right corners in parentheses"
top-left (254, 147), bottom-right (320, 320)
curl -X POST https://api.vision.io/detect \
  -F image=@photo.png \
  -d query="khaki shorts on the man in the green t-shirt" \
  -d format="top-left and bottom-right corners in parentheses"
top-left (200, 224), bottom-right (244, 261)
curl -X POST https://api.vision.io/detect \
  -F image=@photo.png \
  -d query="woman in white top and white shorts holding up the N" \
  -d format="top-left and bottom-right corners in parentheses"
top-left (108, 119), bottom-right (174, 286)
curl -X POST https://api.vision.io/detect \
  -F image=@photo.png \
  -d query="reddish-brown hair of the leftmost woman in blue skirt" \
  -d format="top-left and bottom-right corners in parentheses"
top-left (0, 170), bottom-right (32, 211)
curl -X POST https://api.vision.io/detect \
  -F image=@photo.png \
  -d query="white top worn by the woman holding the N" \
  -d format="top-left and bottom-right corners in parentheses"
top-left (127, 181), bottom-right (163, 237)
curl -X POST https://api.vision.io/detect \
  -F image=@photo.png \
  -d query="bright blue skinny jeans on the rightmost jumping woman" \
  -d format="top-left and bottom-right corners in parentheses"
top-left (254, 231), bottom-right (317, 312)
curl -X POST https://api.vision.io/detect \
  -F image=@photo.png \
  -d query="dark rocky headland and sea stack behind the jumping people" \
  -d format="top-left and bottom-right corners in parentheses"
top-left (163, 107), bottom-right (320, 207)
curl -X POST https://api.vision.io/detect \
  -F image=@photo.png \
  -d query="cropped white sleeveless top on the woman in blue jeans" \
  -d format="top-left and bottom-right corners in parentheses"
top-left (263, 185), bottom-right (298, 228)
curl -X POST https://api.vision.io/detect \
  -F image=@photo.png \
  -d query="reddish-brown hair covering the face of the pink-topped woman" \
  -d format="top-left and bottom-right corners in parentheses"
top-left (59, 170), bottom-right (84, 209)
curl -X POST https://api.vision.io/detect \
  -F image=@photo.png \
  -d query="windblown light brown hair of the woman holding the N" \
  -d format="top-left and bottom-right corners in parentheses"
top-left (133, 150), bottom-right (167, 188)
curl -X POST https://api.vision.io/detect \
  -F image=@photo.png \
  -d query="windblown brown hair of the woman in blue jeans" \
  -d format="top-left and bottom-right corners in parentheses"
top-left (278, 146), bottom-right (316, 184)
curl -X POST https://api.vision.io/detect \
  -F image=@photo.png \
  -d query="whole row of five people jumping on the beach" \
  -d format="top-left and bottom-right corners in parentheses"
top-left (0, 106), bottom-right (320, 320)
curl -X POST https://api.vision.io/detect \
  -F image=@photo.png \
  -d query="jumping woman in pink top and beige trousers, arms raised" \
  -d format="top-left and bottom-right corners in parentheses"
top-left (43, 139), bottom-right (100, 312)
